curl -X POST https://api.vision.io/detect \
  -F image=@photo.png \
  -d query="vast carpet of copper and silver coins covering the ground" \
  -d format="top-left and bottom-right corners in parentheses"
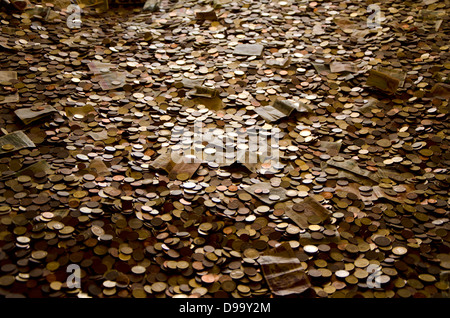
top-left (0, 0), bottom-right (450, 298)
